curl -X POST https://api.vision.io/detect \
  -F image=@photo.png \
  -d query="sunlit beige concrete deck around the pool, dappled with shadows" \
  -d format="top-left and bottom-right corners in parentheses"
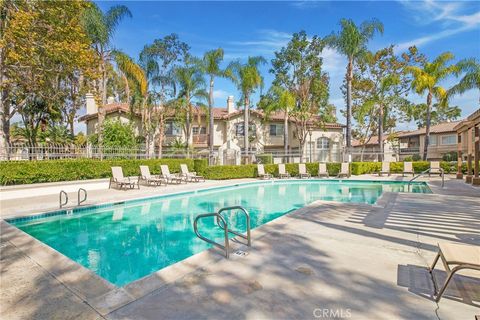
top-left (0, 176), bottom-right (480, 319)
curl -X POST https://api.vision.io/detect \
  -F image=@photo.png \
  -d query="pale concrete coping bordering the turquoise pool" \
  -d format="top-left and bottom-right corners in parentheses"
top-left (0, 179), bottom-right (420, 316)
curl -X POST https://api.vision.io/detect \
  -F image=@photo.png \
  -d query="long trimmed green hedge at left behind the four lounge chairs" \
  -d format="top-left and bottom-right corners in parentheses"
top-left (0, 159), bottom-right (195, 185)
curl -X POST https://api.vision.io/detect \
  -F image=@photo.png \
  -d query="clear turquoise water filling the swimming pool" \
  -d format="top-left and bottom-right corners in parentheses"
top-left (9, 180), bottom-right (430, 286)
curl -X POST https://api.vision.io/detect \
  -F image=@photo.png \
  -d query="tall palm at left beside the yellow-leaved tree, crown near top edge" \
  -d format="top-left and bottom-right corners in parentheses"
top-left (83, 3), bottom-right (132, 146)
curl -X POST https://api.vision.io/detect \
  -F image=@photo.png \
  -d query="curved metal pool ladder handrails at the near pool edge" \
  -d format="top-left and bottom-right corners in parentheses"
top-left (193, 206), bottom-right (252, 259)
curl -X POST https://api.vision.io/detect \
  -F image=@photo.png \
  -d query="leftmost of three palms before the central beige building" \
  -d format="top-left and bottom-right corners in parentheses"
top-left (174, 59), bottom-right (208, 152)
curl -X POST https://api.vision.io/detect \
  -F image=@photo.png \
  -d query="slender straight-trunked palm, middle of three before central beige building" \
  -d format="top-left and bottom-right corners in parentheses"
top-left (199, 48), bottom-right (229, 160)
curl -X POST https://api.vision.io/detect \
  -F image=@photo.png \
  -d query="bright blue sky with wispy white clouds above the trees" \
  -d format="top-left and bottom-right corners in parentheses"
top-left (87, 1), bottom-right (480, 129)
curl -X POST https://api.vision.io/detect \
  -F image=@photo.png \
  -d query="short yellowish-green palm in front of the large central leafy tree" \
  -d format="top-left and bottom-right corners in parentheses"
top-left (260, 85), bottom-right (296, 156)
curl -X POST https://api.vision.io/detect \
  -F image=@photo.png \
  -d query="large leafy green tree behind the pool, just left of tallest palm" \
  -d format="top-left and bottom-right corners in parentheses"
top-left (270, 31), bottom-right (334, 160)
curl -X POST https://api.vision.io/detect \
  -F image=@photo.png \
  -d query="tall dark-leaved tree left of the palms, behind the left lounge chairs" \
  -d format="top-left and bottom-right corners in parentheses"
top-left (140, 33), bottom-right (190, 157)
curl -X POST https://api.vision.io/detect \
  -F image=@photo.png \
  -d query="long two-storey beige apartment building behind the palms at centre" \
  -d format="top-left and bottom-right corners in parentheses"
top-left (79, 95), bottom-right (344, 163)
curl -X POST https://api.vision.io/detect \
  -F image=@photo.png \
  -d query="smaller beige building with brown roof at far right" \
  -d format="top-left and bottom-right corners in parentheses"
top-left (397, 121), bottom-right (460, 160)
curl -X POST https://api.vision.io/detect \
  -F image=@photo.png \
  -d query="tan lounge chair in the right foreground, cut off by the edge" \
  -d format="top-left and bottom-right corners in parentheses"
top-left (429, 243), bottom-right (480, 302)
